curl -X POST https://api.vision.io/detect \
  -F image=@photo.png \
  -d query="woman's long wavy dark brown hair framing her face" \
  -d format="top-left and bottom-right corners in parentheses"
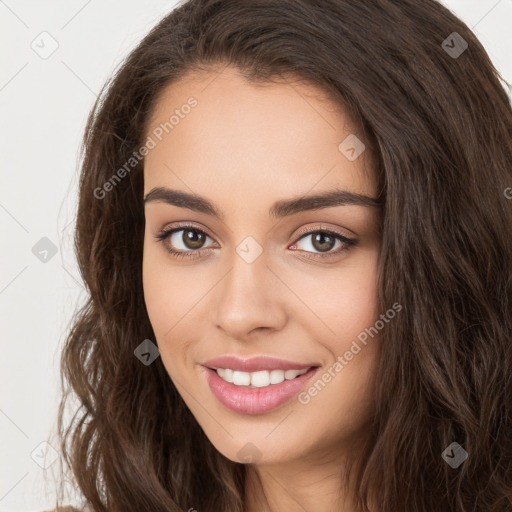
top-left (58, 0), bottom-right (512, 512)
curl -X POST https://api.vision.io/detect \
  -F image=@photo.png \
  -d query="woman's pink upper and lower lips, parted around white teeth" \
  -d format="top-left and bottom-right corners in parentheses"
top-left (202, 356), bottom-right (318, 415)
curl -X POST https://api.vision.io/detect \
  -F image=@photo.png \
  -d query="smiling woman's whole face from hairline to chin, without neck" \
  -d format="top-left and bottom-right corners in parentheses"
top-left (143, 67), bottom-right (380, 464)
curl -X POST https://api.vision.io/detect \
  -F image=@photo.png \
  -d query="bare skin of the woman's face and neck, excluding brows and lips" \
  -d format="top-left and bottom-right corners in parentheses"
top-left (143, 67), bottom-right (380, 512)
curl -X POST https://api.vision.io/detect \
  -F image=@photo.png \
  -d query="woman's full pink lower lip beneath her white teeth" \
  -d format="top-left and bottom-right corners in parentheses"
top-left (205, 367), bottom-right (318, 414)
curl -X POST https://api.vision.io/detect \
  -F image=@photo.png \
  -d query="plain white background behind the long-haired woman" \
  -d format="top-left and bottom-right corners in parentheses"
top-left (0, 0), bottom-right (512, 512)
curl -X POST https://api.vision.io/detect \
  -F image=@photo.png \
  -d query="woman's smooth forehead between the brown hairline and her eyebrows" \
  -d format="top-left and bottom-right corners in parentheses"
top-left (144, 67), bottom-right (377, 202)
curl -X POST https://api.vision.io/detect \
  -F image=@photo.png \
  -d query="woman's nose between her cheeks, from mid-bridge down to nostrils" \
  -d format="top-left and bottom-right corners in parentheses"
top-left (212, 244), bottom-right (290, 340)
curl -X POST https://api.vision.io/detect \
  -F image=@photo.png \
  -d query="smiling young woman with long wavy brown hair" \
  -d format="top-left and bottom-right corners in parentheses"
top-left (52, 0), bottom-right (512, 512)
